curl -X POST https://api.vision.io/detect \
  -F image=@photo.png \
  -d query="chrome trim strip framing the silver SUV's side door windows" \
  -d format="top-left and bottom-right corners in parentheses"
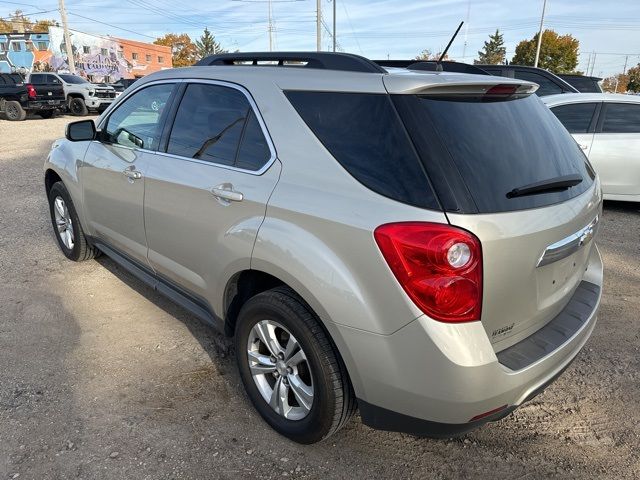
top-left (98, 78), bottom-right (278, 176)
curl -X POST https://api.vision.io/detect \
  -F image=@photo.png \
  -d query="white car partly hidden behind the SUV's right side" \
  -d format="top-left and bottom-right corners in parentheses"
top-left (543, 93), bottom-right (640, 202)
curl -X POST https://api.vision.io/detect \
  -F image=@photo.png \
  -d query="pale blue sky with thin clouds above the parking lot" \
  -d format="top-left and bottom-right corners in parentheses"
top-left (0, 0), bottom-right (640, 76)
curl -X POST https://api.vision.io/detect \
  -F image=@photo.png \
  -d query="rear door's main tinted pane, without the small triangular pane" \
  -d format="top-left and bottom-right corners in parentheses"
top-left (167, 84), bottom-right (251, 165)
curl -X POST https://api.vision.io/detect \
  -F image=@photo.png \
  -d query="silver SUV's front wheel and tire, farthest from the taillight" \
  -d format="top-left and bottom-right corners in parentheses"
top-left (49, 182), bottom-right (99, 262)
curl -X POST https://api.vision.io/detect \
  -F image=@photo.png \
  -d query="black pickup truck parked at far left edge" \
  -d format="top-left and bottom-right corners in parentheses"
top-left (0, 73), bottom-right (64, 121)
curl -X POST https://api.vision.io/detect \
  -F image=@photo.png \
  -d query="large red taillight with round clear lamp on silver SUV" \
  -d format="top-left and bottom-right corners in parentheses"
top-left (374, 222), bottom-right (482, 322)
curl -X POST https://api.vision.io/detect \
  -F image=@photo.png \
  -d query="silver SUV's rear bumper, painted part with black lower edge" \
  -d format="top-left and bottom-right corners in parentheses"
top-left (340, 248), bottom-right (602, 437)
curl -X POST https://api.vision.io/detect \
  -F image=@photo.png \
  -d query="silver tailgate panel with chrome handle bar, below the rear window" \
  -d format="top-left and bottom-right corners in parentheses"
top-left (448, 182), bottom-right (602, 351)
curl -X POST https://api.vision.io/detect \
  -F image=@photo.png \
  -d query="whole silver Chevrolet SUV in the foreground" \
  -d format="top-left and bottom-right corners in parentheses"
top-left (45, 53), bottom-right (602, 443)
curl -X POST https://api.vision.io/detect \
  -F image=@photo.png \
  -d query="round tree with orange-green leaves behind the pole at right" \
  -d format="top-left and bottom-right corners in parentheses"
top-left (511, 30), bottom-right (580, 73)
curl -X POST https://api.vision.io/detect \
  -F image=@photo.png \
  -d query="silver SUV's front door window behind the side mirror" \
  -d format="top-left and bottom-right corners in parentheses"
top-left (103, 83), bottom-right (174, 150)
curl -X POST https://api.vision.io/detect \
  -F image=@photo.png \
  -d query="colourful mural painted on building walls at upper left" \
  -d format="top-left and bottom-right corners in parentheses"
top-left (0, 27), bottom-right (134, 82)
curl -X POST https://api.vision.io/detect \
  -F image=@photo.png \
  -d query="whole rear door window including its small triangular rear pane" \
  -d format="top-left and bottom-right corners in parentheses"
top-left (167, 83), bottom-right (270, 170)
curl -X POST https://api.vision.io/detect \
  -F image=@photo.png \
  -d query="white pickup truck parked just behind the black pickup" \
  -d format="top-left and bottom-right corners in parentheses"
top-left (28, 72), bottom-right (116, 116)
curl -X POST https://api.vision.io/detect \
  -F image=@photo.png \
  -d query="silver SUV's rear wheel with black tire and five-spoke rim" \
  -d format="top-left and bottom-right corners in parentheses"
top-left (235, 287), bottom-right (356, 444)
